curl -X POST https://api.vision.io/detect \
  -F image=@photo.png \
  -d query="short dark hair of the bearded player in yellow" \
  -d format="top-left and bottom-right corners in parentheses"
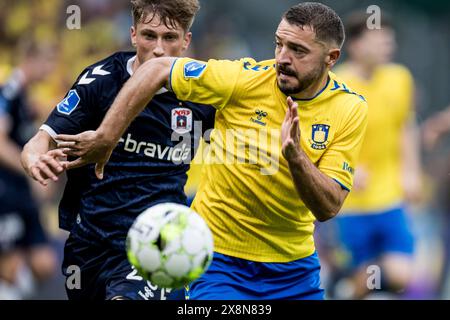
top-left (283, 2), bottom-right (345, 47)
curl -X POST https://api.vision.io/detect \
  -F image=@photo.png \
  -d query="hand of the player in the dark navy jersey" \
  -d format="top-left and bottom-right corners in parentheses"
top-left (24, 149), bottom-right (68, 186)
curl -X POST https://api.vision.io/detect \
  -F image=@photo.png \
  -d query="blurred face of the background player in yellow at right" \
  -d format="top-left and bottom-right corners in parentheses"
top-left (349, 28), bottom-right (396, 65)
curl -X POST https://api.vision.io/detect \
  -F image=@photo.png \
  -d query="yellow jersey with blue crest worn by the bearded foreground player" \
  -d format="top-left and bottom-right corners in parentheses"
top-left (169, 58), bottom-right (367, 262)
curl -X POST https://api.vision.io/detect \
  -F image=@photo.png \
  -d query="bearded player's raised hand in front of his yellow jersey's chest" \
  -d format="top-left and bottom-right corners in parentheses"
top-left (281, 97), bottom-right (302, 161)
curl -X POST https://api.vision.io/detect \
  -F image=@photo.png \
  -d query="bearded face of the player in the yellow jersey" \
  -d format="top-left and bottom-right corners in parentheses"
top-left (275, 19), bottom-right (329, 95)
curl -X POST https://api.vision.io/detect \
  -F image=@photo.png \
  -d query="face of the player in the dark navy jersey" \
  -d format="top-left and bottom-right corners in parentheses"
top-left (131, 13), bottom-right (192, 63)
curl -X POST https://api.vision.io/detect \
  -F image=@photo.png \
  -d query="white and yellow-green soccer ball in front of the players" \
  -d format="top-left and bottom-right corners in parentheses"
top-left (126, 203), bottom-right (213, 289)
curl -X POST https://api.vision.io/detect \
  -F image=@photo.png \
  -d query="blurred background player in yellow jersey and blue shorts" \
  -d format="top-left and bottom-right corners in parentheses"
top-left (330, 13), bottom-right (420, 298)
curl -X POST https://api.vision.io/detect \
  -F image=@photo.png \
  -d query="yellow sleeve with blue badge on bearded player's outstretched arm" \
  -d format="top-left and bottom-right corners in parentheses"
top-left (169, 58), bottom-right (242, 110)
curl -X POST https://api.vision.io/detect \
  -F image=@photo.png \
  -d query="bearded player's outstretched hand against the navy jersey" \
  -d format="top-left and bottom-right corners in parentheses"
top-left (55, 131), bottom-right (116, 180)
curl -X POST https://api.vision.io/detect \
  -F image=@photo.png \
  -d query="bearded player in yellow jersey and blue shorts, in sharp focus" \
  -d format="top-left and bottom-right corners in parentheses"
top-left (58, 3), bottom-right (367, 299)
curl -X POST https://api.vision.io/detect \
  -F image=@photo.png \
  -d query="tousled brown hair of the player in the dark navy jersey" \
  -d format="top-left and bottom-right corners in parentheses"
top-left (131, 0), bottom-right (200, 31)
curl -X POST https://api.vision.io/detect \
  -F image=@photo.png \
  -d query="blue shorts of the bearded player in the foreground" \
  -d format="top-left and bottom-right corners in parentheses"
top-left (186, 252), bottom-right (324, 300)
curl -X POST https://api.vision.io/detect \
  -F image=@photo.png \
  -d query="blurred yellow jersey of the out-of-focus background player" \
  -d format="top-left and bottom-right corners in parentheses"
top-left (336, 64), bottom-right (414, 214)
